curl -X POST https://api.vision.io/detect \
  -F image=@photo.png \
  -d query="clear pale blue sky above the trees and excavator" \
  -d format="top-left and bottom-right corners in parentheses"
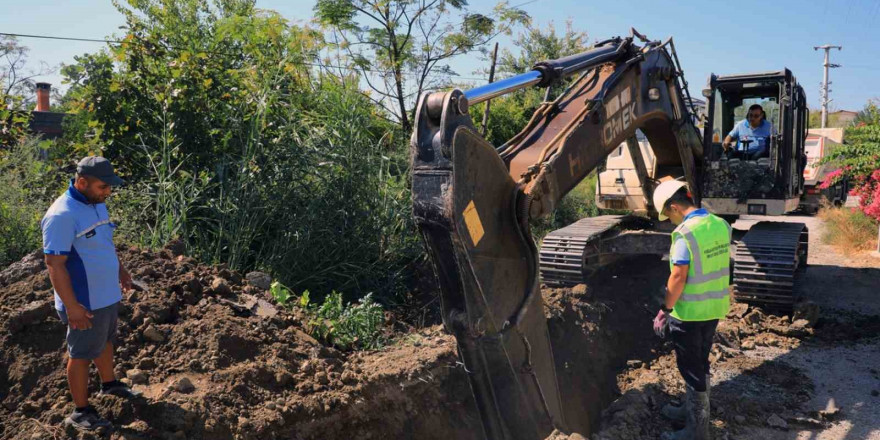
top-left (0, 0), bottom-right (880, 110)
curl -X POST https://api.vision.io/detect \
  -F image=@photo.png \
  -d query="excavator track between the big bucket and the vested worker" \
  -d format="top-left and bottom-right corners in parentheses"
top-left (540, 215), bottom-right (625, 287)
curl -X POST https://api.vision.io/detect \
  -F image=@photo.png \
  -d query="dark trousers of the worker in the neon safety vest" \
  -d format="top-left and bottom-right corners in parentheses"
top-left (669, 316), bottom-right (718, 392)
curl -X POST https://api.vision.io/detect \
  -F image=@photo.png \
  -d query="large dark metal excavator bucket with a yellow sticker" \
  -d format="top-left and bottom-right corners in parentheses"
top-left (413, 91), bottom-right (563, 439)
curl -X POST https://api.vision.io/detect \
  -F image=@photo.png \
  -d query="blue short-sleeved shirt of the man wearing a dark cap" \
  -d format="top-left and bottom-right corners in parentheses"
top-left (40, 181), bottom-right (122, 311)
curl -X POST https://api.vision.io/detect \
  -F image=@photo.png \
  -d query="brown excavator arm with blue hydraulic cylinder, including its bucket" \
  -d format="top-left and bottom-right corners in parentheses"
top-left (411, 31), bottom-right (702, 439)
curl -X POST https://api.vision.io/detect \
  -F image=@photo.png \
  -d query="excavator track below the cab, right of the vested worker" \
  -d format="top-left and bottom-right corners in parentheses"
top-left (733, 222), bottom-right (809, 311)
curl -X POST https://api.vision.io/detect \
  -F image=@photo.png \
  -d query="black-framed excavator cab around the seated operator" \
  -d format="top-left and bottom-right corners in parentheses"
top-left (701, 69), bottom-right (808, 216)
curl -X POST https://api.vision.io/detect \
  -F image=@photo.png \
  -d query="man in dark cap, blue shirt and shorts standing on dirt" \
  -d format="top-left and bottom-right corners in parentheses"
top-left (40, 156), bottom-right (138, 431)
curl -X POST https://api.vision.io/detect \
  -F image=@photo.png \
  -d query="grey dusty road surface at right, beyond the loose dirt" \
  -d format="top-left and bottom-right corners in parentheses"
top-left (735, 217), bottom-right (880, 440)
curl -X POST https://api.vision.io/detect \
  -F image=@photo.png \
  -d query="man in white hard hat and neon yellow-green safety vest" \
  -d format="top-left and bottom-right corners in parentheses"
top-left (653, 180), bottom-right (731, 440)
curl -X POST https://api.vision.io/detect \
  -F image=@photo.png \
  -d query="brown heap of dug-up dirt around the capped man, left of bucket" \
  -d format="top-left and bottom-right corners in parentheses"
top-left (0, 248), bottom-right (479, 439)
